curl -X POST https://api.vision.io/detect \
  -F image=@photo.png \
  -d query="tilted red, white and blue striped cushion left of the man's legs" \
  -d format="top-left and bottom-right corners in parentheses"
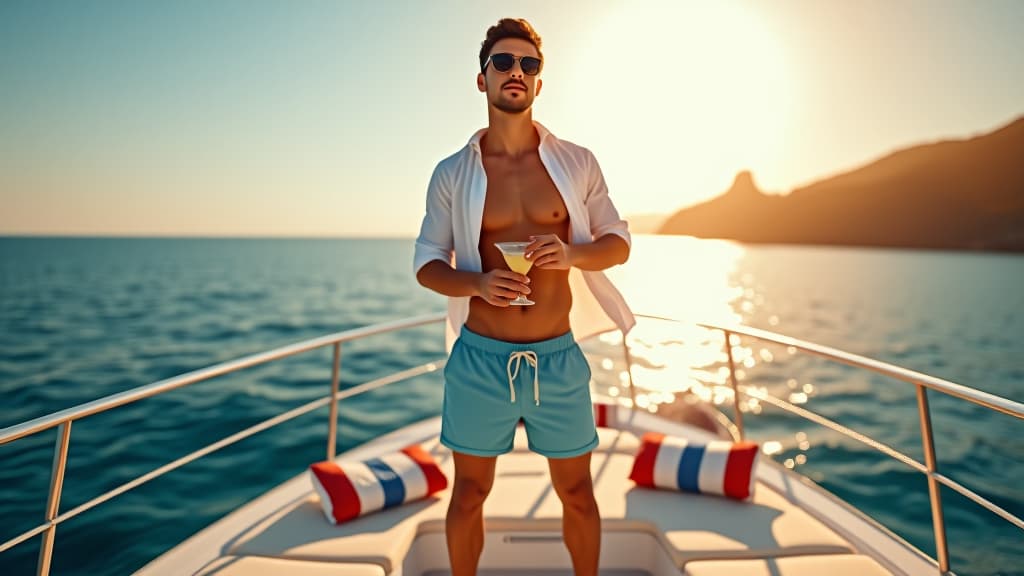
top-left (309, 445), bottom-right (447, 524)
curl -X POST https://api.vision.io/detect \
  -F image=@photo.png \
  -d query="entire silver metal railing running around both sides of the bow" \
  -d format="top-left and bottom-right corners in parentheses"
top-left (0, 314), bottom-right (1024, 575)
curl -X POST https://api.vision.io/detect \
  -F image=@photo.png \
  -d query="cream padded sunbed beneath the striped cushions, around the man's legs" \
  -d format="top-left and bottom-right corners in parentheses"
top-left (224, 428), bottom-right (854, 573)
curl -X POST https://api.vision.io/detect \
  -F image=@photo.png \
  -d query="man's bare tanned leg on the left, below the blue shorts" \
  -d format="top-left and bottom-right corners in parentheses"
top-left (444, 452), bottom-right (498, 576)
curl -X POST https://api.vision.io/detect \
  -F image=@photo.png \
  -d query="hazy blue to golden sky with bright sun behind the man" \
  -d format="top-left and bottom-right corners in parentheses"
top-left (0, 0), bottom-right (1024, 237)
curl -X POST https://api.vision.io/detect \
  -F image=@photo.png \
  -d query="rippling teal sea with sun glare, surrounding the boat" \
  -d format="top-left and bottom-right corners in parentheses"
top-left (0, 236), bottom-right (1024, 576)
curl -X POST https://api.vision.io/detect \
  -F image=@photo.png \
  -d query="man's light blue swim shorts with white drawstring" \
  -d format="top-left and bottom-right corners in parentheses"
top-left (441, 327), bottom-right (598, 458)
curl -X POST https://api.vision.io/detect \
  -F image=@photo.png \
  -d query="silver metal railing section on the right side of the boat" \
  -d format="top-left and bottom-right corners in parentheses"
top-left (700, 317), bottom-right (1024, 574)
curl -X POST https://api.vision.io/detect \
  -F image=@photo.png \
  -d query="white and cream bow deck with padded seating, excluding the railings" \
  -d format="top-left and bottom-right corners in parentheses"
top-left (139, 413), bottom-right (938, 576)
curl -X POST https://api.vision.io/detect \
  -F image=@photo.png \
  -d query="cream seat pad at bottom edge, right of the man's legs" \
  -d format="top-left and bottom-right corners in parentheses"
top-left (683, 554), bottom-right (892, 576)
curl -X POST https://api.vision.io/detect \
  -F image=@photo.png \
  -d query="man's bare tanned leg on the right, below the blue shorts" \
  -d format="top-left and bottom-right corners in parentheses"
top-left (548, 452), bottom-right (601, 576)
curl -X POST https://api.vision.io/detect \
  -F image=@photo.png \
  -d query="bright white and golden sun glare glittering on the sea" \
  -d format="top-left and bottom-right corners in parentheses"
top-left (585, 236), bottom-right (816, 450)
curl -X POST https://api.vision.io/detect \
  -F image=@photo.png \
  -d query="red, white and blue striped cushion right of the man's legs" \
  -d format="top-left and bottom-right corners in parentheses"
top-left (630, 433), bottom-right (758, 500)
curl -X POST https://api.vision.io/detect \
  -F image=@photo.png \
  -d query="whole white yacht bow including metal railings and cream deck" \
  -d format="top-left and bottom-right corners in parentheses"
top-left (0, 314), bottom-right (1024, 576)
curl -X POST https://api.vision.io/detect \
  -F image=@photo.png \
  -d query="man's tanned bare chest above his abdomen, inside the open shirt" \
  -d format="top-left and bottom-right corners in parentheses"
top-left (482, 157), bottom-right (567, 231)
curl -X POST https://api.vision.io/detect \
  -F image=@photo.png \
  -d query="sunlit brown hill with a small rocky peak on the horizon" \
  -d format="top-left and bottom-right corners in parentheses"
top-left (658, 118), bottom-right (1024, 251)
